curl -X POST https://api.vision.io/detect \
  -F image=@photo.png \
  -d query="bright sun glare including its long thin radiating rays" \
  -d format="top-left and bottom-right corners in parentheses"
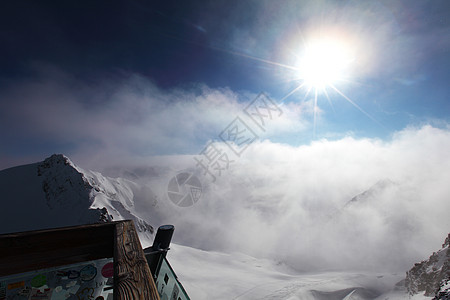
top-left (221, 30), bottom-right (384, 136)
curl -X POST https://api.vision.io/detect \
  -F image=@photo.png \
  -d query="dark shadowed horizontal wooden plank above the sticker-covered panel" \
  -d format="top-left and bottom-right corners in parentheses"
top-left (0, 222), bottom-right (116, 277)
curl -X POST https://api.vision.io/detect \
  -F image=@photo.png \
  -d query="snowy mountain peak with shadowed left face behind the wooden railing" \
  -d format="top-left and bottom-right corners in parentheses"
top-left (0, 154), bottom-right (154, 240)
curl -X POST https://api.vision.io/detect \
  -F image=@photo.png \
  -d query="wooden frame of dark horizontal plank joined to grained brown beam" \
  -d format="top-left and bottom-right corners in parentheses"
top-left (0, 220), bottom-right (160, 300)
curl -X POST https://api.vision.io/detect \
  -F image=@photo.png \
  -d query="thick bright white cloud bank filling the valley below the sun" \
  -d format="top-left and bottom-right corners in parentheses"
top-left (145, 126), bottom-right (450, 272)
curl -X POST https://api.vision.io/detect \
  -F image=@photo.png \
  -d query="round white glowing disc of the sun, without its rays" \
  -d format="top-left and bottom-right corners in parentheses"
top-left (296, 38), bottom-right (354, 91)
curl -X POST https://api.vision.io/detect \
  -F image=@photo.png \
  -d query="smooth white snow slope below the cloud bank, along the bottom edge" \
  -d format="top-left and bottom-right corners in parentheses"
top-left (168, 245), bottom-right (431, 300)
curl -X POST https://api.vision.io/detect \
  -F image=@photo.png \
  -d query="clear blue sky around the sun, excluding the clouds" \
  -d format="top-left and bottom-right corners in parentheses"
top-left (0, 0), bottom-right (450, 169)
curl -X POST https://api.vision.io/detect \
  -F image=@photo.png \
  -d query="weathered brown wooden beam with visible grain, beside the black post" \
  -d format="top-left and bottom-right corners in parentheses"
top-left (114, 221), bottom-right (160, 300)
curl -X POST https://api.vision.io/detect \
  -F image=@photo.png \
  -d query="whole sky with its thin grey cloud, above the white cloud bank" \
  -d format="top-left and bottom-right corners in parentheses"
top-left (0, 1), bottom-right (450, 168)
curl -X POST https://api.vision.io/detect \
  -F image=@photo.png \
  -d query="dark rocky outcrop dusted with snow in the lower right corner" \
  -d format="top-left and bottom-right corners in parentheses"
top-left (405, 233), bottom-right (450, 299)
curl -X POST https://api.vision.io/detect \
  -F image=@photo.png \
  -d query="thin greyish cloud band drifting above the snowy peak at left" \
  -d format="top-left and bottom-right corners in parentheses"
top-left (0, 66), bottom-right (308, 170)
